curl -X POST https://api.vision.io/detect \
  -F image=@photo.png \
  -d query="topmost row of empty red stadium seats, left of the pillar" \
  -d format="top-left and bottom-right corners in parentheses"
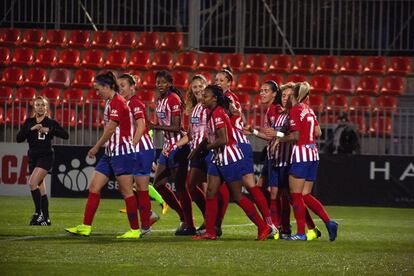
top-left (0, 29), bottom-right (183, 50)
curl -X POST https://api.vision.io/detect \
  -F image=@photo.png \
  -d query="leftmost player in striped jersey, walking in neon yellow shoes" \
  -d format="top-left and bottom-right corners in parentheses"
top-left (65, 72), bottom-right (141, 239)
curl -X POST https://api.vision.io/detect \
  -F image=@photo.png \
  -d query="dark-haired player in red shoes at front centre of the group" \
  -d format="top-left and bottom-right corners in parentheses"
top-left (189, 85), bottom-right (272, 240)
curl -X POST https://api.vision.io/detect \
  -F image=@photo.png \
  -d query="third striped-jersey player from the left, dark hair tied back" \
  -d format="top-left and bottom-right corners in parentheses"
top-left (149, 71), bottom-right (195, 235)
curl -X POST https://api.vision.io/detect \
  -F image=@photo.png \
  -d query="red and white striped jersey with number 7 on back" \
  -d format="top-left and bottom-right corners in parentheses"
top-left (289, 103), bottom-right (319, 163)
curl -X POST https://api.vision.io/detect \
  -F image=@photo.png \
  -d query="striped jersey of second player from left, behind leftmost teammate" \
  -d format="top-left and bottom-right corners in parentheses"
top-left (127, 95), bottom-right (154, 152)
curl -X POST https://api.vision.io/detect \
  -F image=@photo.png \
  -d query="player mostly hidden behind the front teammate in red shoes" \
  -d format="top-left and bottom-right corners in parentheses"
top-left (216, 69), bottom-right (277, 231)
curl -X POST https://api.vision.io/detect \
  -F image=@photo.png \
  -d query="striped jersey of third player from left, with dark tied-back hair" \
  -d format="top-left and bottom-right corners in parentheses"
top-left (155, 92), bottom-right (183, 150)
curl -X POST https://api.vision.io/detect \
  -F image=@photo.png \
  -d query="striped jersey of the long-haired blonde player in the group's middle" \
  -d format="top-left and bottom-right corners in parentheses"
top-left (190, 103), bottom-right (208, 150)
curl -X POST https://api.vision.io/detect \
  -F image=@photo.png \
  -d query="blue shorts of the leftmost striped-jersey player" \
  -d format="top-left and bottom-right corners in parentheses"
top-left (95, 153), bottom-right (136, 177)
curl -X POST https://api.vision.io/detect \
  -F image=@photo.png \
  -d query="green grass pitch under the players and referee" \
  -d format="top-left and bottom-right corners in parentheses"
top-left (0, 197), bottom-right (414, 275)
